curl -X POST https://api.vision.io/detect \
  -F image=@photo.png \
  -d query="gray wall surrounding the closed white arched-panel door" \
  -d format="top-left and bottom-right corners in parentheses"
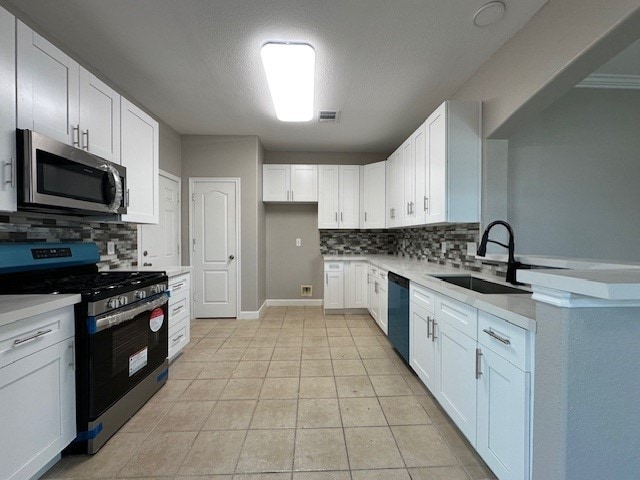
top-left (182, 135), bottom-right (266, 311)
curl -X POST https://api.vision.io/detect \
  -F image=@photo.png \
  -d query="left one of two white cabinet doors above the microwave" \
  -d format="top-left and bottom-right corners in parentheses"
top-left (17, 21), bottom-right (80, 146)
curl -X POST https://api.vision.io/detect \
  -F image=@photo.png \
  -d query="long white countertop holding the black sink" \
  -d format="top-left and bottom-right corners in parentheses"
top-left (323, 255), bottom-right (536, 332)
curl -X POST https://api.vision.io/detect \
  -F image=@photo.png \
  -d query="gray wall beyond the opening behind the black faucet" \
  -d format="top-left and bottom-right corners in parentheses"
top-left (508, 89), bottom-right (640, 261)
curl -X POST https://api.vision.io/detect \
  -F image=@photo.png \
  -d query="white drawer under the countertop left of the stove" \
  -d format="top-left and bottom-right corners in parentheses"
top-left (0, 306), bottom-right (75, 367)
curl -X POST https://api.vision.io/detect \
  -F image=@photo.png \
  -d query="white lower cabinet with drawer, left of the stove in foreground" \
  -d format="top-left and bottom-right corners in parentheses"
top-left (0, 306), bottom-right (76, 480)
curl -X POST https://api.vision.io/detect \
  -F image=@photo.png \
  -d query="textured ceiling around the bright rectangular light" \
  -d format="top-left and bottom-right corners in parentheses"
top-left (5, 0), bottom-right (546, 152)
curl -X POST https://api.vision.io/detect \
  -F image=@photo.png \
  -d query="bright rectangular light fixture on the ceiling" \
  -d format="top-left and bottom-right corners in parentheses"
top-left (260, 43), bottom-right (316, 122)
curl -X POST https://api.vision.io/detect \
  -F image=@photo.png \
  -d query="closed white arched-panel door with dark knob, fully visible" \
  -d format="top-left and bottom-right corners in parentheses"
top-left (191, 180), bottom-right (239, 318)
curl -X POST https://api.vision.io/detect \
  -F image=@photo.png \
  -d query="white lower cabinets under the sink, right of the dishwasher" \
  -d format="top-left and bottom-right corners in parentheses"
top-left (409, 284), bottom-right (533, 480)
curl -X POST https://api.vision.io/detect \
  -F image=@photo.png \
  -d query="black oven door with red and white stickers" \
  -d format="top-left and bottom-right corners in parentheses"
top-left (88, 293), bottom-right (169, 419)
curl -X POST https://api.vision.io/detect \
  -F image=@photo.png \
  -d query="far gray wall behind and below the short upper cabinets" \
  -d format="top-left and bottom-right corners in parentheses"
top-left (260, 152), bottom-right (388, 299)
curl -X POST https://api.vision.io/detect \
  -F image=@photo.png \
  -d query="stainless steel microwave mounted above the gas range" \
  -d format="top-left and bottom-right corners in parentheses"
top-left (16, 129), bottom-right (128, 215)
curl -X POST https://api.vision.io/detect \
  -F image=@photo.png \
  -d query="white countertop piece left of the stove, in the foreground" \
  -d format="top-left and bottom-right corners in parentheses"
top-left (0, 294), bottom-right (81, 326)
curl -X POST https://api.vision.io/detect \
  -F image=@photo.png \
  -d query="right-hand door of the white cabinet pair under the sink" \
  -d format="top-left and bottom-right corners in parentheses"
top-left (432, 319), bottom-right (477, 446)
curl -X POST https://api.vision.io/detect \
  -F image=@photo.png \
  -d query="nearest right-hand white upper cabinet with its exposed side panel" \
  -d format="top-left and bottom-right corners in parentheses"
top-left (425, 101), bottom-right (482, 224)
